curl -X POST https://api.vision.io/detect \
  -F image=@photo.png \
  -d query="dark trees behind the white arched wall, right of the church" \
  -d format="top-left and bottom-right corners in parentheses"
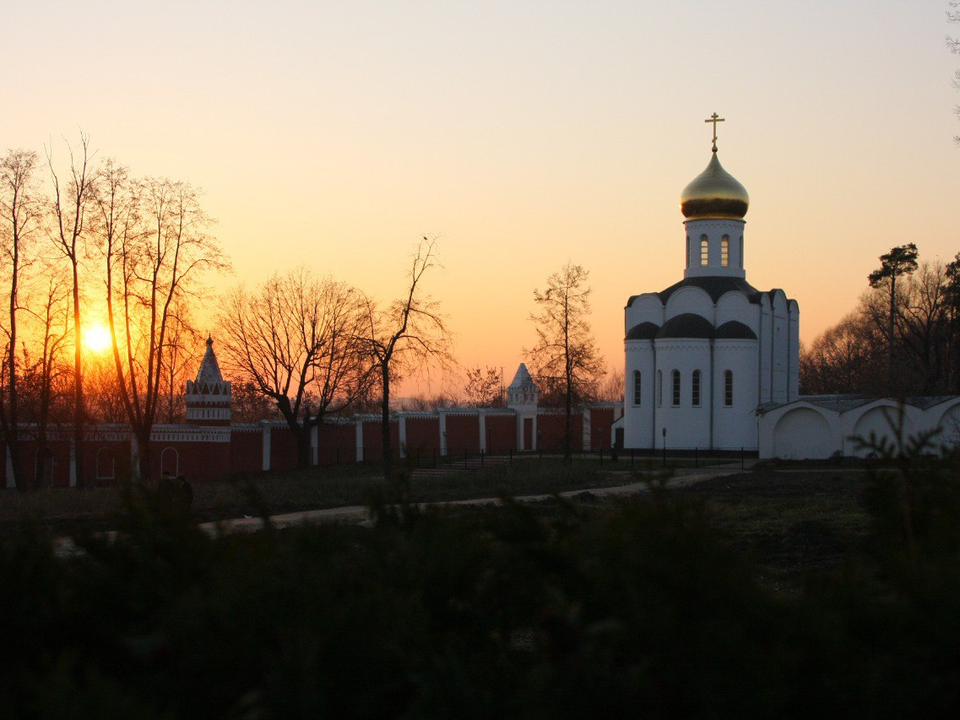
top-left (800, 243), bottom-right (960, 397)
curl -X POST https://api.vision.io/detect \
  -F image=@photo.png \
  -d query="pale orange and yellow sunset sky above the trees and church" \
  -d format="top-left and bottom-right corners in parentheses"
top-left (0, 0), bottom-right (960, 394)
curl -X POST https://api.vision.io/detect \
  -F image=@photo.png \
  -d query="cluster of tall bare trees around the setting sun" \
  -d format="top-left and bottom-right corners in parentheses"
top-left (0, 141), bottom-right (228, 490)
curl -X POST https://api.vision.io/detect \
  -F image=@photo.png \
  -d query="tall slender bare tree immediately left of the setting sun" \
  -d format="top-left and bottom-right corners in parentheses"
top-left (47, 134), bottom-right (96, 487)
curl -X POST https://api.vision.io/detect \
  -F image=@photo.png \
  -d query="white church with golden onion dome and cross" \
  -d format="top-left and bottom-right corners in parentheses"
top-left (618, 113), bottom-right (800, 451)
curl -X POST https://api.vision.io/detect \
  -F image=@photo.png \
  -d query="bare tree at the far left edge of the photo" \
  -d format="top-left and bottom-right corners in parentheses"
top-left (0, 150), bottom-right (40, 491)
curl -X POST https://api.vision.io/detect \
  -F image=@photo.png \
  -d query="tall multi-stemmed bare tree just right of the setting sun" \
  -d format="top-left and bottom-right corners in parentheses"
top-left (97, 172), bottom-right (228, 479)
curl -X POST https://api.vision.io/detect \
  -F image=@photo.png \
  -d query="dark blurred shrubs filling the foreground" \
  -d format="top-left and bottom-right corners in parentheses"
top-left (0, 468), bottom-right (960, 718)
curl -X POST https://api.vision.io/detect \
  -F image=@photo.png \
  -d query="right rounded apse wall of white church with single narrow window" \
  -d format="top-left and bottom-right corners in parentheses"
top-left (713, 340), bottom-right (758, 450)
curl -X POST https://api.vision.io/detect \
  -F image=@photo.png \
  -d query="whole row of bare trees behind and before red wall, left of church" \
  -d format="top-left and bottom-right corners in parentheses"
top-left (0, 135), bottom-right (622, 490)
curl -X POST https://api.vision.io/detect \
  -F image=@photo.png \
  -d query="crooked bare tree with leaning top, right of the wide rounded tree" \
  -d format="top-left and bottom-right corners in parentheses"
top-left (363, 237), bottom-right (452, 480)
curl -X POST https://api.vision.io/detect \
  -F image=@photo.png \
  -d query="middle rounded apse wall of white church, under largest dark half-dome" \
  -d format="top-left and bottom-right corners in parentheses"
top-left (654, 338), bottom-right (711, 448)
